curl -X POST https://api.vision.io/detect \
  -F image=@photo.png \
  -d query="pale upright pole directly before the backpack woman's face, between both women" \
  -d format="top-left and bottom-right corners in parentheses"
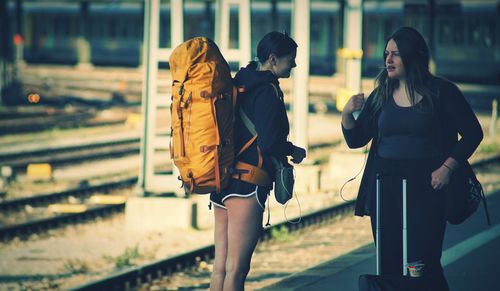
top-left (292, 0), bottom-right (311, 150)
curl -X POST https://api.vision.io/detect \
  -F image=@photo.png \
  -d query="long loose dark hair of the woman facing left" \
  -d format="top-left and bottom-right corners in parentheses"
top-left (375, 27), bottom-right (436, 110)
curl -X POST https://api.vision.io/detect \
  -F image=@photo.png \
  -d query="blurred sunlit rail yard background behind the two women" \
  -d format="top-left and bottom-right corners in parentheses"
top-left (0, 0), bottom-right (500, 290)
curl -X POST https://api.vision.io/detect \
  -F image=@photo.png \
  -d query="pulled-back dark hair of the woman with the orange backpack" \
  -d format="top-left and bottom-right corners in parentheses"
top-left (247, 31), bottom-right (297, 69)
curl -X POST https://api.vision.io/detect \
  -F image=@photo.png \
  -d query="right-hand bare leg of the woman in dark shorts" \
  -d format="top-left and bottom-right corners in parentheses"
top-left (223, 196), bottom-right (263, 291)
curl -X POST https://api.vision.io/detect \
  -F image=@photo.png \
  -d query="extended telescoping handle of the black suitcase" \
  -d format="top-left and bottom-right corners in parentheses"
top-left (375, 174), bottom-right (408, 276)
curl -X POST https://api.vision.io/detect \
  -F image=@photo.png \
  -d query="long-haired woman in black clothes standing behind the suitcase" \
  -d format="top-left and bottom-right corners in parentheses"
top-left (342, 27), bottom-right (483, 291)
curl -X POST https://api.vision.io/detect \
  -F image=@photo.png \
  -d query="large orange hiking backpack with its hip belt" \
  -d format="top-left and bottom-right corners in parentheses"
top-left (169, 37), bottom-right (270, 194)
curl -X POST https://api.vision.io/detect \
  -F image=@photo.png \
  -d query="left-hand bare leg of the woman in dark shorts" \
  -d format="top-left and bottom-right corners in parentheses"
top-left (210, 204), bottom-right (227, 291)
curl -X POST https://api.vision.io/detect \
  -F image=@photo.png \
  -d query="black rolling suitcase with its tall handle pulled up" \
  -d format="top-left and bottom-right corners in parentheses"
top-left (359, 174), bottom-right (428, 291)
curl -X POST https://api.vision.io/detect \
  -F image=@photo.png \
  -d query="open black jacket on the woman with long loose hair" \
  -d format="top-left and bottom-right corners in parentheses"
top-left (342, 77), bottom-right (483, 216)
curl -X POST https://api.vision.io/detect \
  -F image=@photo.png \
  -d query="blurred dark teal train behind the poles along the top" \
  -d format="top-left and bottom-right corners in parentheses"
top-left (4, 0), bottom-right (500, 84)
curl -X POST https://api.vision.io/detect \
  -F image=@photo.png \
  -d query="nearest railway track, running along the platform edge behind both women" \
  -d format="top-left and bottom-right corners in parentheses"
top-left (67, 156), bottom-right (500, 291)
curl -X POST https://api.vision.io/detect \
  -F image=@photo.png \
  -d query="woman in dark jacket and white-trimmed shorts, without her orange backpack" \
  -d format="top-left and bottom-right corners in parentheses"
top-left (210, 32), bottom-right (306, 290)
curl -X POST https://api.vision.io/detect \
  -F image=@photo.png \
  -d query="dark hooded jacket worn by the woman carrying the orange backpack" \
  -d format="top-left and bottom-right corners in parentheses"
top-left (224, 68), bottom-right (292, 193)
